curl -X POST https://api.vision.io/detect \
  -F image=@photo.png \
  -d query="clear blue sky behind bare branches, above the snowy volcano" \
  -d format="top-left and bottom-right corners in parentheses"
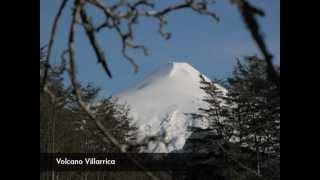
top-left (40, 0), bottom-right (280, 96)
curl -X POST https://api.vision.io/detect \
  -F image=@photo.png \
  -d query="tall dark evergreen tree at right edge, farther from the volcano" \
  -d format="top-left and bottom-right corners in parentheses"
top-left (228, 56), bottom-right (280, 175)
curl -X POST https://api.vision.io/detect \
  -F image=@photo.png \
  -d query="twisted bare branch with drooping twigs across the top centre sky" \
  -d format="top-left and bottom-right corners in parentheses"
top-left (76, 0), bottom-right (219, 72)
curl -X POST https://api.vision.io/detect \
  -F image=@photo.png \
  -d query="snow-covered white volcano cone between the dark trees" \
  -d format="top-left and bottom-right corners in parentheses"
top-left (114, 62), bottom-right (226, 153)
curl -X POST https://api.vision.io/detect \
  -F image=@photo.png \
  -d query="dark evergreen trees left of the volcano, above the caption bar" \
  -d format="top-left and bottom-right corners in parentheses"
top-left (40, 49), bottom-right (135, 153)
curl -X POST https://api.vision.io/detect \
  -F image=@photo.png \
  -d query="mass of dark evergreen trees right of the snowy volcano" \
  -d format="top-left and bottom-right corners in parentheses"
top-left (185, 56), bottom-right (280, 179)
